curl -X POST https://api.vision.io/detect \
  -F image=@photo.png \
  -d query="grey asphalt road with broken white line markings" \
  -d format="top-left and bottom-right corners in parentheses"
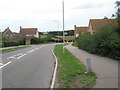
top-left (0, 44), bottom-right (55, 88)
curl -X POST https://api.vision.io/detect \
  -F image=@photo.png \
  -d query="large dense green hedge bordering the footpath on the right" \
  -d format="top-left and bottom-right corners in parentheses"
top-left (77, 25), bottom-right (120, 60)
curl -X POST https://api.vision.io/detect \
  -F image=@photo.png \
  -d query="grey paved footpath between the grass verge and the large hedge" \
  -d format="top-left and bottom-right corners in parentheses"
top-left (66, 45), bottom-right (118, 88)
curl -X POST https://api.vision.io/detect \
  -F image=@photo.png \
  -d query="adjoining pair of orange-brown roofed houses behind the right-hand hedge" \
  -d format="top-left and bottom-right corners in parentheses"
top-left (74, 18), bottom-right (117, 37)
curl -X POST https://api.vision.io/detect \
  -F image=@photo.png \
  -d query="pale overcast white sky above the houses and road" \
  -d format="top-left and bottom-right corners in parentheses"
top-left (0, 0), bottom-right (116, 32)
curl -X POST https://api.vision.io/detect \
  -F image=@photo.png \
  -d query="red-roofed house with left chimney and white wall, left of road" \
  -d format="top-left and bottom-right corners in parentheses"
top-left (19, 27), bottom-right (39, 38)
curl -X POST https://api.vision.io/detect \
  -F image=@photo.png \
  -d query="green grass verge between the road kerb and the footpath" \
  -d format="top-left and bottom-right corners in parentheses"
top-left (54, 45), bottom-right (96, 88)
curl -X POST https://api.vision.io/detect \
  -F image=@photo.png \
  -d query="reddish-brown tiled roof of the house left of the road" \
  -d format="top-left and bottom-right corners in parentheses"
top-left (20, 28), bottom-right (38, 35)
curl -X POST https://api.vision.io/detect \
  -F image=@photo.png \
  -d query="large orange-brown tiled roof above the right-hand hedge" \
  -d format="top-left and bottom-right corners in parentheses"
top-left (89, 19), bottom-right (117, 31)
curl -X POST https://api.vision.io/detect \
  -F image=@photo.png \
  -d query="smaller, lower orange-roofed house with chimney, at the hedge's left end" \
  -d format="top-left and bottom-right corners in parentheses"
top-left (74, 25), bottom-right (89, 37)
